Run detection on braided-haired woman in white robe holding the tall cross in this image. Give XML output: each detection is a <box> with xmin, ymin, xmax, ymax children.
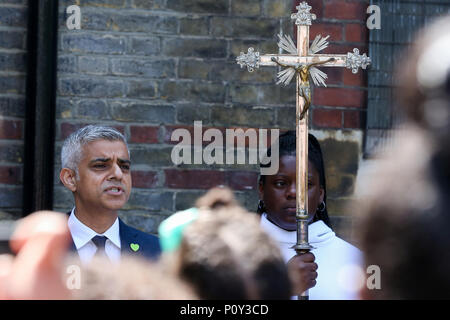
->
<box><xmin>258</xmin><ymin>131</ymin><xmax>362</xmax><ymax>300</ymax></box>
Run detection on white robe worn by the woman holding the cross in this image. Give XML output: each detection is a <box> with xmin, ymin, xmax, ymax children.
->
<box><xmin>261</xmin><ymin>213</ymin><xmax>365</xmax><ymax>300</ymax></box>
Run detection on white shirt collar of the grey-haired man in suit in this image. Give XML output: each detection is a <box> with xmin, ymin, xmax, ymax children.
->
<box><xmin>68</xmin><ymin>207</ymin><xmax>120</xmax><ymax>249</ymax></box>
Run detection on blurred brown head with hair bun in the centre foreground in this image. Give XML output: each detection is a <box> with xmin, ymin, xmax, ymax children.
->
<box><xmin>163</xmin><ymin>189</ymin><xmax>290</xmax><ymax>299</ymax></box>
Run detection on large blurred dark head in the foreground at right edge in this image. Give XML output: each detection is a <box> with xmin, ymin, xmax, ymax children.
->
<box><xmin>360</xmin><ymin>16</ymin><xmax>450</xmax><ymax>299</ymax></box>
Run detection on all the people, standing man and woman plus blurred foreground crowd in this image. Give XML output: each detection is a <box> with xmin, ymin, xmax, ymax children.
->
<box><xmin>0</xmin><ymin>17</ymin><xmax>450</xmax><ymax>300</ymax></box>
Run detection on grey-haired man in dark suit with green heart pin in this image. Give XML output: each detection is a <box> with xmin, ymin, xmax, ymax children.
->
<box><xmin>60</xmin><ymin>125</ymin><xmax>161</xmax><ymax>263</ymax></box>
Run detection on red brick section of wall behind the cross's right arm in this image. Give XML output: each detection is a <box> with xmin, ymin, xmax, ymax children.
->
<box><xmin>306</xmin><ymin>0</ymin><xmax>369</xmax><ymax>129</ymax></box>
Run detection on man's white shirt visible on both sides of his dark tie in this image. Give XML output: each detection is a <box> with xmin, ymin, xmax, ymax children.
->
<box><xmin>68</xmin><ymin>208</ymin><xmax>120</xmax><ymax>264</ymax></box>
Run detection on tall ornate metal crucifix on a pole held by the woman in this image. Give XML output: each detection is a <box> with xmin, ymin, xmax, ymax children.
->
<box><xmin>236</xmin><ymin>2</ymin><xmax>370</xmax><ymax>300</ymax></box>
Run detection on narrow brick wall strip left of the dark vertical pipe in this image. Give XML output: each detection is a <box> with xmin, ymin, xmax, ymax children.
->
<box><xmin>0</xmin><ymin>0</ymin><xmax>27</xmax><ymax>219</ymax></box>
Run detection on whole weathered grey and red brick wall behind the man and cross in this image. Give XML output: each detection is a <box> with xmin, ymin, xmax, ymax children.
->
<box><xmin>0</xmin><ymin>0</ymin><xmax>368</xmax><ymax>244</ymax></box>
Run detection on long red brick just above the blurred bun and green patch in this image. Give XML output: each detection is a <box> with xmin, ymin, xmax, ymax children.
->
<box><xmin>164</xmin><ymin>169</ymin><xmax>225</xmax><ymax>189</ymax></box>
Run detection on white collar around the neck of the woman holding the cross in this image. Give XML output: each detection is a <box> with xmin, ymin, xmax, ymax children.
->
<box><xmin>261</xmin><ymin>213</ymin><xmax>335</xmax><ymax>246</ymax></box>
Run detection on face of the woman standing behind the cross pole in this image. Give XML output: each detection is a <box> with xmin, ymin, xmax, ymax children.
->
<box><xmin>258</xmin><ymin>156</ymin><xmax>324</xmax><ymax>231</ymax></box>
